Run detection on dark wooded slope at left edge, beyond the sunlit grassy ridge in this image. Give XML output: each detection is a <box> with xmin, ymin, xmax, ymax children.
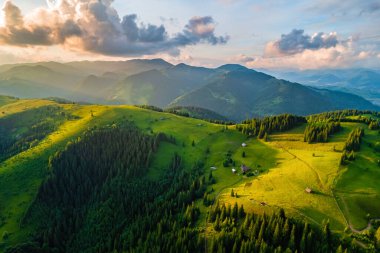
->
<box><xmin>0</xmin><ymin>106</ymin><xmax>73</xmax><ymax>161</ymax></box>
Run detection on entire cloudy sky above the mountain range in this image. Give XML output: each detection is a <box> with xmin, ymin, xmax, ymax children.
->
<box><xmin>0</xmin><ymin>0</ymin><xmax>380</xmax><ymax>70</ymax></box>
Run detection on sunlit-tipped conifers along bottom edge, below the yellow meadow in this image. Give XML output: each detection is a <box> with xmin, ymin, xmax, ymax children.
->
<box><xmin>208</xmin><ymin>203</ymin><xmax>342</xmax><ymax>253</ymax></box>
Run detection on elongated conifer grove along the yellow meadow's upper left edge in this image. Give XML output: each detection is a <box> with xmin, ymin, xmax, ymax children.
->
<box><xmin>236</xmin><ymin>114</ymin><xmax>306</xmax><ymax>139</ymax></box>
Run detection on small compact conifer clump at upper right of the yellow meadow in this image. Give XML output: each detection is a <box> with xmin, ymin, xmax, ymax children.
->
<box><xmin>304</xmin><ymin>121</ymin><xmax>341</xmax><ymax>143</ymax></box>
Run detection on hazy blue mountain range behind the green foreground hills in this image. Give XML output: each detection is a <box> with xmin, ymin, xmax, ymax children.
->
<box><xmin>0</xmin><ymin>59</ymin><xmax>380</xmax><ymax>120</ymax></box>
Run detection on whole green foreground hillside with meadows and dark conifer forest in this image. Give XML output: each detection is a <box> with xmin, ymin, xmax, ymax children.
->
<box><xmin>0</xmin><ymin>99</ymin><xmax>380</xmax><ymax>252</ymax></box>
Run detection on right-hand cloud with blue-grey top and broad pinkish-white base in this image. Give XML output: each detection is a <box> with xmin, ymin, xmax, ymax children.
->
<box><xmin>238</xmin><ymin>29</ymin><xmax>378</xmax><ymax>69</ymax></box>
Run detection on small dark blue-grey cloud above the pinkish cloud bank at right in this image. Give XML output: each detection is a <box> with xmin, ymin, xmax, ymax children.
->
<box><xmin>274</xmin><ymin>29</ymin><xmax>339</xmax><ymax>54</ymax></box>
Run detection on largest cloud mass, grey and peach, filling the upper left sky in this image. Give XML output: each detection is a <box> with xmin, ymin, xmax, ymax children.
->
<box><xmin>0</xmin><ymin>0</ymin><xmax>229</xmax><ymax>56</ymax></box>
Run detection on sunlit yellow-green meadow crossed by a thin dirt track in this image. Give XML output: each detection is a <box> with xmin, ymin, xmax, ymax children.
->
<box><xmin>215</xmin><ymin>122</ymin><xmax>358</xmax><ymax>230</ymax></box>
